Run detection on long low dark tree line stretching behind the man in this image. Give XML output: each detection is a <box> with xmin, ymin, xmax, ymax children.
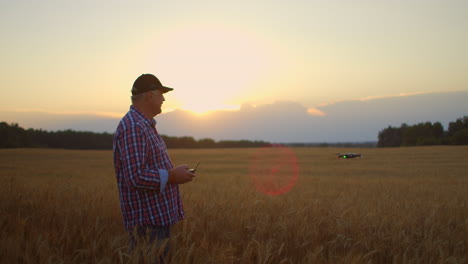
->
<box><xmin>0</xmin><ymin>122</ymin><xmax>269</xmax><ymax>150</ymax></box>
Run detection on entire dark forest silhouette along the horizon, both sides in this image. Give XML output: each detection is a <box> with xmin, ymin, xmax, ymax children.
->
<box><xmin>0</xmin><ymin>116</ymin><xmax>468</xmax><ymax>150</ymax></box>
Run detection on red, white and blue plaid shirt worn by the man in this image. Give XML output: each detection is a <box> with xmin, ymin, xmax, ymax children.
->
<box><xmin>114</xmin><ymin>106</ymin><xmax>184</xmax><ymax>231</ymax></box>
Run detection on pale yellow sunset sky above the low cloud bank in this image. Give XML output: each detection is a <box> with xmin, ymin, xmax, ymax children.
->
<box><xmin>0</xmin><ymin>0</ymin><xmax>468</xmax><ymax>141</ymax></box>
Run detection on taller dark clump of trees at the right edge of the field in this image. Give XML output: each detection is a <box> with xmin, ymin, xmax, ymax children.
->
<box><xmin>377</xmin><ymin>116</ymin><xmax>468</xmax><ymax>147</ymax></box>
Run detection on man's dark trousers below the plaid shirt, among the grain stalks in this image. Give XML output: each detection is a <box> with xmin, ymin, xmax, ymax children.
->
<box><xmin>130</xmin><ymin>226</ymin><xmax>171</xmax><ymax>264</ymax></box>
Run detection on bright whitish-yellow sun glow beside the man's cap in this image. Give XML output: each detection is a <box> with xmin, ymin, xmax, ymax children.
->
<box><xmin>151</xmin><ymin>24</ymin><xmax>284</xmax><ymax>114</ymax></box>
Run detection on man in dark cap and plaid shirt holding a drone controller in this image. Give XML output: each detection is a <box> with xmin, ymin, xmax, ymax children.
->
<box><xmin>114</xmin><ymin>74</ymin><xmax>195</xmax><ymax>254</ymax></box>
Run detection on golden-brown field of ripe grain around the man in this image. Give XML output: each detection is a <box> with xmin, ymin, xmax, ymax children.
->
<box><xmin>0</xmin><ymin>146</ymin><xmax>468</xmax><ymax>263</ymax></box>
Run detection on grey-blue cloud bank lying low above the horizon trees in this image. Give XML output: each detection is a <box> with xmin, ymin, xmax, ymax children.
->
<box><xmin>0</xmin><ymin>91</ymin><xmax>468</xmax><ymax>143</ymax></box>
